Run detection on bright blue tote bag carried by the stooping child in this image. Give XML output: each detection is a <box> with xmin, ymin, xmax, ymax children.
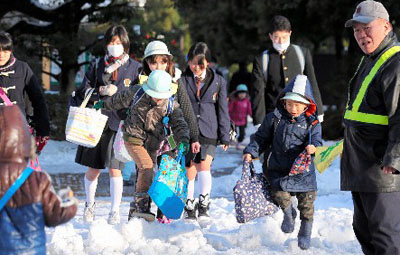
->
<box><xmin>148</xmin><ymin>152</ymin><xmax>188</xmax><ymax>219</ymax></box>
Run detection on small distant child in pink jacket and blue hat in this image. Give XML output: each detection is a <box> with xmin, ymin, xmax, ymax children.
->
<box><xmin>229</xmin><ymin>84</ymin><xmax>252</xmax><ymax>150</ymax></box>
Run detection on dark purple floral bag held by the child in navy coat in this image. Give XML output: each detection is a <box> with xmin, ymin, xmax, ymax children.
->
<box><xmin>233</xmin><ymin>162</ymin><xmax>278</xmax><ymax>223</ymax></box>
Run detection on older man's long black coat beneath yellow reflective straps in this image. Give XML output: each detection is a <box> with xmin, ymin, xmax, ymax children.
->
<box><xmin>341</xmin><ymin>33</ymin><xmax>400</xmax><ymax>192</ymax></box>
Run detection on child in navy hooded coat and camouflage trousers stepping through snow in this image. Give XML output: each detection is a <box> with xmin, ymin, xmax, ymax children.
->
<box><xmin>243</xmin><ymin>75</ymin><xmax>322</xmax><ymax>250</ymax></box>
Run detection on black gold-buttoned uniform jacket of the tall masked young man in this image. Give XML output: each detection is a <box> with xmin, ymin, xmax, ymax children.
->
<box><xmin>250</xmin><ymin>45</ymin><xmax>324</xmax><ymax>125</ymax></box>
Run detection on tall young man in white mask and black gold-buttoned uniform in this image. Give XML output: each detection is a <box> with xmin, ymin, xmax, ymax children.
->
<box><xmin>249</xmin><ymin>16</ymin><xmax>323</xmax><ymax>125</ymax></box>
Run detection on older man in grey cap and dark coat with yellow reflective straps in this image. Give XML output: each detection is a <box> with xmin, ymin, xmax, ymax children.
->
<box><xmin>341</xmin><ymin>1</ymin><xmax>400</xmax><ymax>255</ymax></box>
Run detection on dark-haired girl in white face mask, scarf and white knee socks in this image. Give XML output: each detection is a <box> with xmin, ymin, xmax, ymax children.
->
<box><xmin>75</xmin><ymin>25</ymin><xmax>140</xmax><ymax>224</ymax></box>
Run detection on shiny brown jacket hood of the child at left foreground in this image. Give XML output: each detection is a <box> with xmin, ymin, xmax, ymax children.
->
<box><xmin>0</xmin><ymin>105</ymin><xmax>31</xmax><ymax>164</ymax></box>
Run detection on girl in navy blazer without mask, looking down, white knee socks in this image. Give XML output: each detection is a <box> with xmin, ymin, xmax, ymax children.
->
<box><xmin>179</xmin><ymin>42</ymin><xmax>230</xmax><ymax>219</ymax></box>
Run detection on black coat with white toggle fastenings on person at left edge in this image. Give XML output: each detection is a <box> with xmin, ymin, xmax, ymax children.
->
<box><xmin>0</xmin><ymin>59</ymin><xmax>50</xmax><ymax>136</ymax></box>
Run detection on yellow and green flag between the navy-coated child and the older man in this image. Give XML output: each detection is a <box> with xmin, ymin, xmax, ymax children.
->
<box><xmin>314</xmin><ymin>140</ymin><xmax>343</xmax><ymax>174</ymax></box>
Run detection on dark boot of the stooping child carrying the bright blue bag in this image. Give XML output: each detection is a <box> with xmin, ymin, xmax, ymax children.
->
<box><xmin>128</xmin><ymin>193</ymin><xmax>155</xmax><ymax>222</ymax></box>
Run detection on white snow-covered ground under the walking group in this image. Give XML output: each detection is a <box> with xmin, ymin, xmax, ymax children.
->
<box><xmin>40</xmin><ymin>127</ymin><xmax>362</xmax><ymax>255</ymax></box>
